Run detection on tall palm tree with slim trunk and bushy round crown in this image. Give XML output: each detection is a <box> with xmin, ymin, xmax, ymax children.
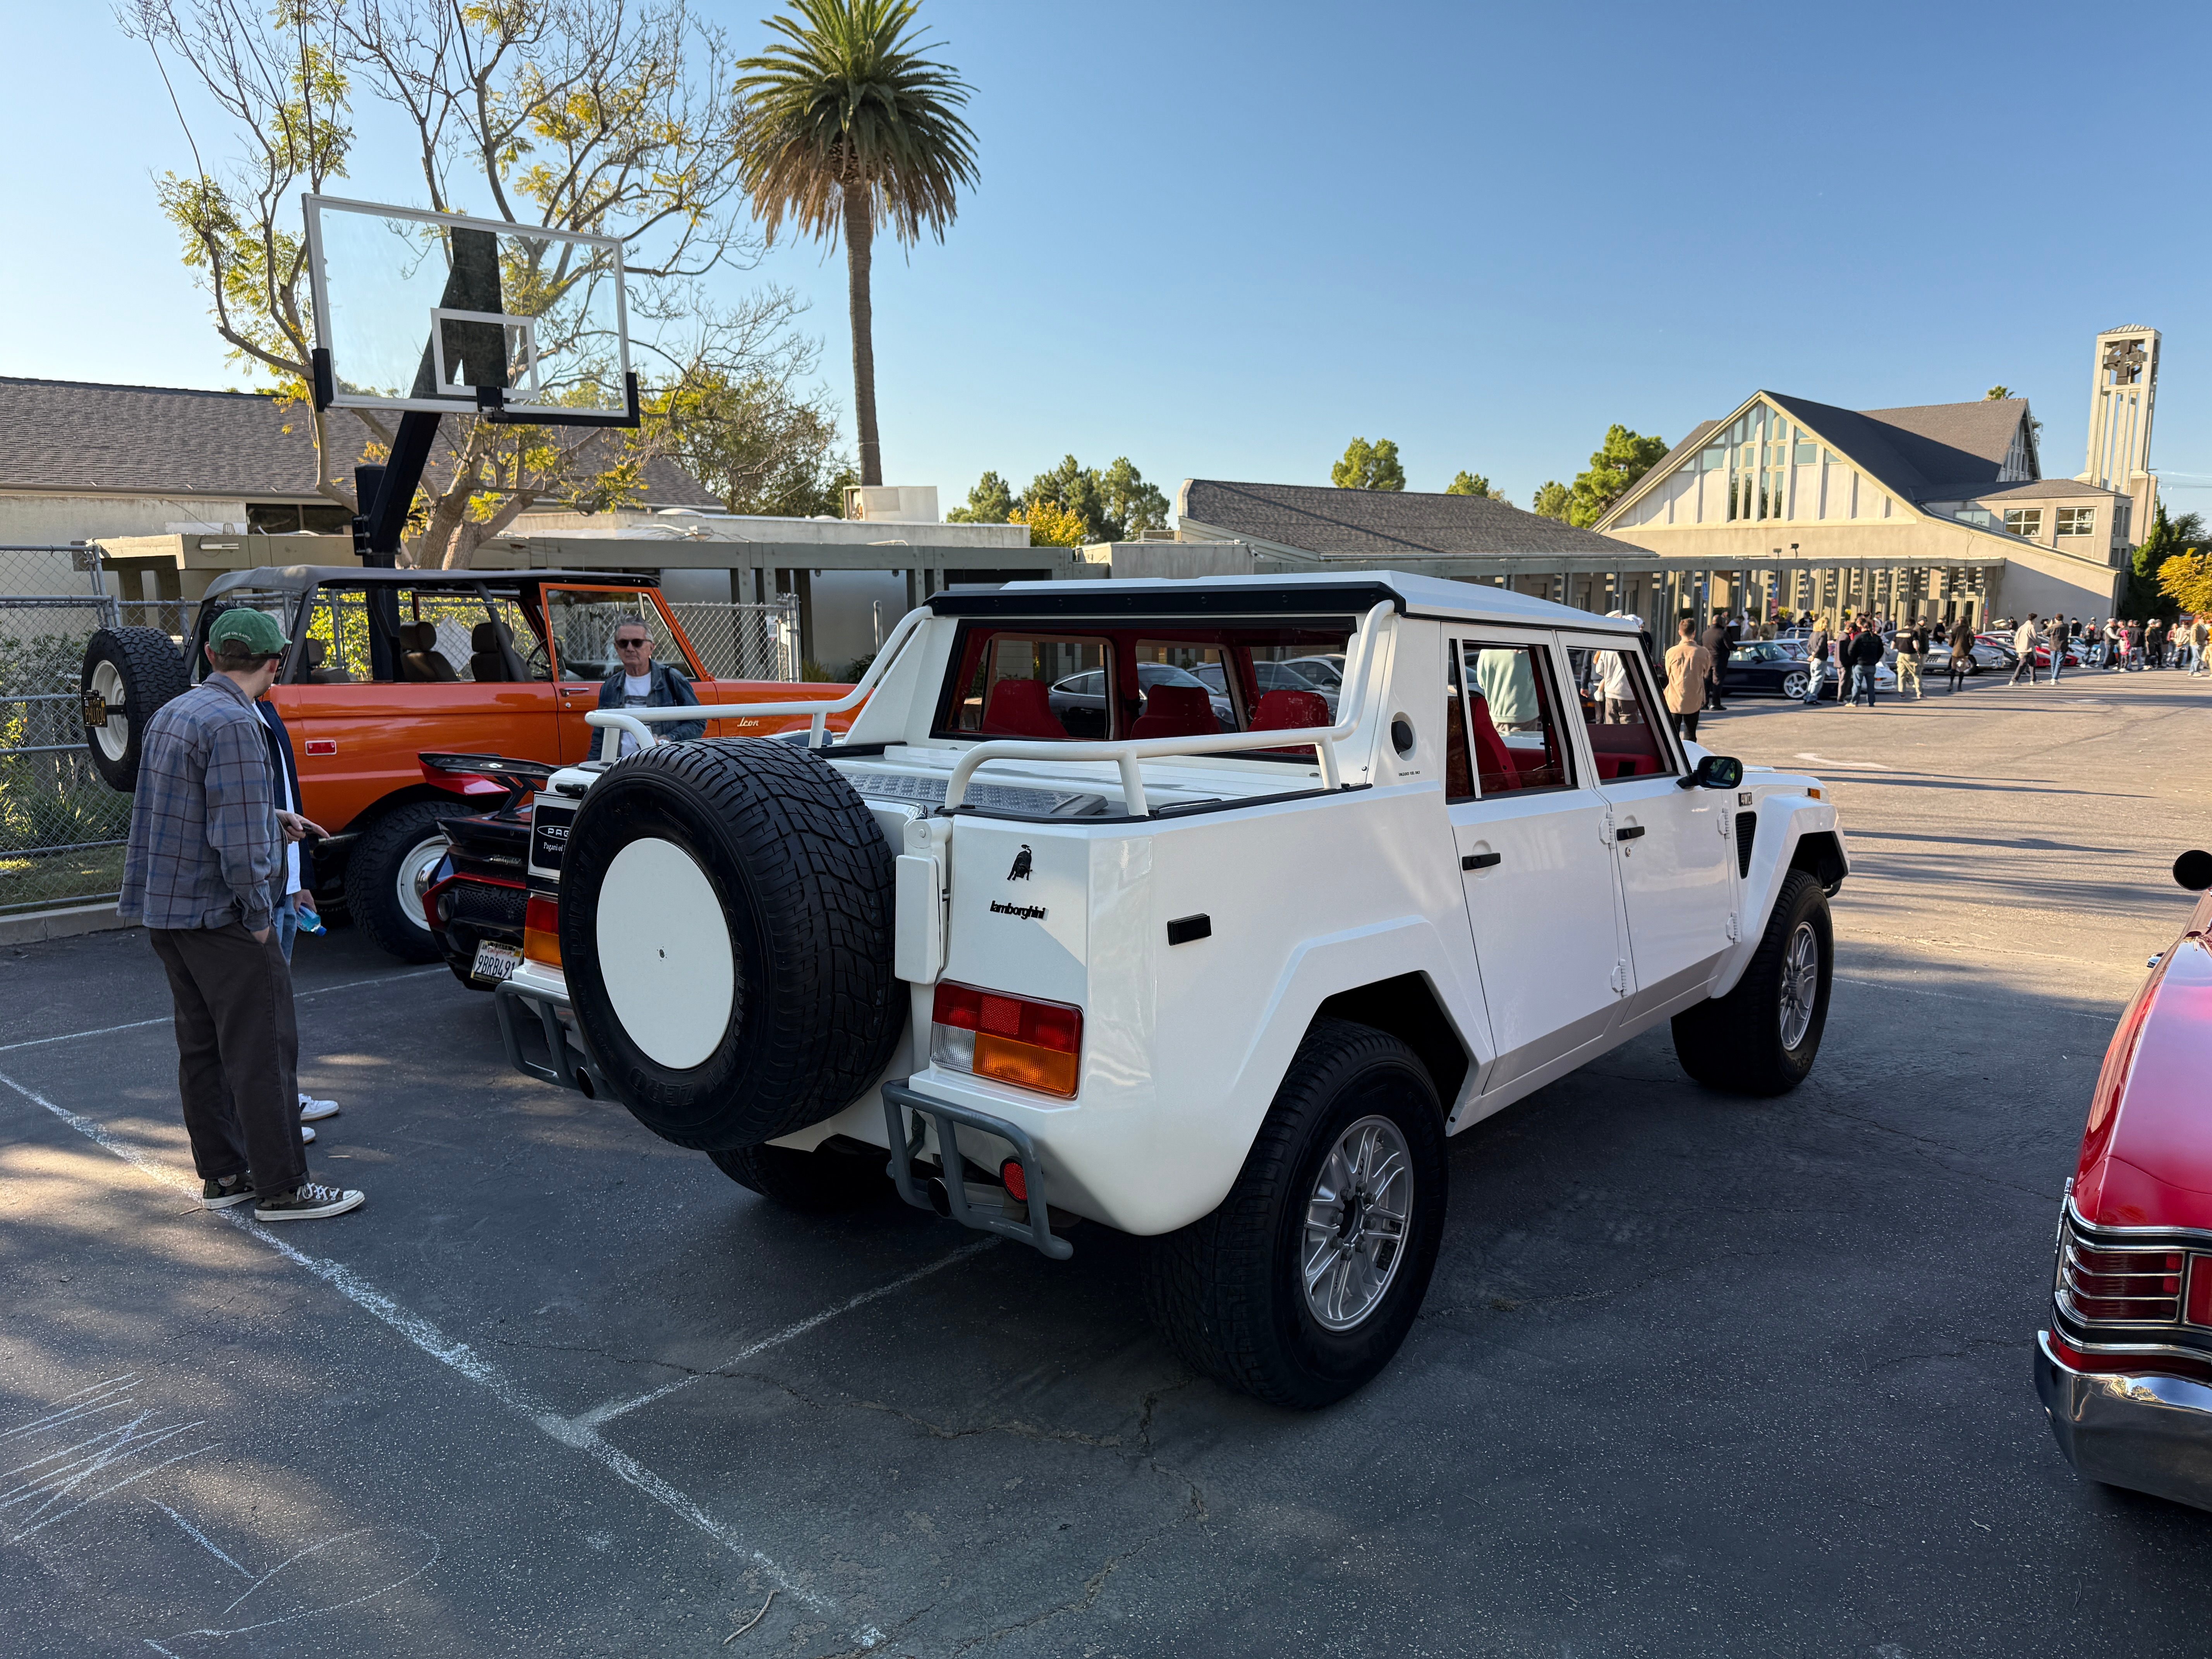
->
<box><xmin>737</xmin><ymin>0</ymin><xmax>975</xmax><ymax>484</ymax></box>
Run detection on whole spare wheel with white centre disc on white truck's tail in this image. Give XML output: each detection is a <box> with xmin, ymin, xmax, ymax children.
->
<box><xmin>560</xmin><ymin>739</ymin><xmax>907</xmax><ymax>1150</ymax></box>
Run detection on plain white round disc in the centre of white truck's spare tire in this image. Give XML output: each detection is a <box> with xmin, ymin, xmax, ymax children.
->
<box><xmin>595</xmin><ymin>836</ymin><xmax>737</xmax><ymax>1071</ymax></box>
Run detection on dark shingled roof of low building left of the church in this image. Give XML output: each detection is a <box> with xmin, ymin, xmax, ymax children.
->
<box><xmin>1177</xmin><ymin>478</ymin><xmax>1654</xmax><ymax>560</ymax></box>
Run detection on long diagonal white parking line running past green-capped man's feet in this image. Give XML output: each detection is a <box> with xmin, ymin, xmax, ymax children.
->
<box><xmin>0</xmin><ymin>1070</ymin><xmax>883</xmax><ymax>1648</ymax></box>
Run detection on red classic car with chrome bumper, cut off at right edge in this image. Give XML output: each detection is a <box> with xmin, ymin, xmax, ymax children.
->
<box><xmin>2035</xmin><ymin>852</ymin><xmax>2212</xmax><ymax>1509</ymax></box>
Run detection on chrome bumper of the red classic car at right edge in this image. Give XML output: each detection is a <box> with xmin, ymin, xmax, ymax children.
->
<box><xmin>2035</xmin><ymin>1332</ymin><xmax>2212</xmax><ymax>1509</ymax></box>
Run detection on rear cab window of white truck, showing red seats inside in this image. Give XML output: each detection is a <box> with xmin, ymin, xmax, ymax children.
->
<box><xmin>933</xmin><ymin>617</ymin><xmax>1352</xmax><ymax>761</ymax></box>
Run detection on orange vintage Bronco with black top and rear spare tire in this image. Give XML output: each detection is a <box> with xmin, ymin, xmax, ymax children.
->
<box><xmin>82</xmin><ymin>564</ymin><xmax>852</xmax><ymax>962</ymax></box>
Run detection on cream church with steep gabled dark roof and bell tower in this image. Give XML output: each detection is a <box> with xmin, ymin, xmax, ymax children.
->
<box><xmin>1597</xmin><ymin>336</ymin><xmax>2154</xmax><ymax>619</ymax></box>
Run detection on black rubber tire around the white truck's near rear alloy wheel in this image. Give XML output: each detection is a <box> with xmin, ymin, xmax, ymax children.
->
<box><xmin>1144</xmin><ymin>1018</ymin><xmax>1449</xmax><ymax>1411</ymax></box>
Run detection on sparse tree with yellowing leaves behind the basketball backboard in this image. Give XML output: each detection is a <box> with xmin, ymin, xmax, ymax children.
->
<box><xmin>119</xmin><ymin>0</ymin><xmax>787</xmax><ymax>566</ymax></box>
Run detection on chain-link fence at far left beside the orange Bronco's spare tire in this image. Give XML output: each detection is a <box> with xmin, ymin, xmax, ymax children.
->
<box><xmin>0</xmin><ymin>546</ymin><xmax>140</xmax><ymax>916</ymax></box>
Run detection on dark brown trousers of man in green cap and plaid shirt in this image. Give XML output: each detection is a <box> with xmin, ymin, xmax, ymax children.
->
<box><xmin>146</xmin><ymin>922</ymin><xmax>307</xmax><ymax>1197</ymax></box>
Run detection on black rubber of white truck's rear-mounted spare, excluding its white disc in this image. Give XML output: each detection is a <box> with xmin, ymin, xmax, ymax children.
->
<box><xmin>560</xmin><ymin>739</ymin><xmax>907</xmax><ymax>1150</ymax></box>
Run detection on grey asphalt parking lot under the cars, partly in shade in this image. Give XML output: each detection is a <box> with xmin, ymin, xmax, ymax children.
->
<box><xmin>0</xmin><ymin>675</ymin><xmax>2212</xmax><ymax>1659</ymax></box>
